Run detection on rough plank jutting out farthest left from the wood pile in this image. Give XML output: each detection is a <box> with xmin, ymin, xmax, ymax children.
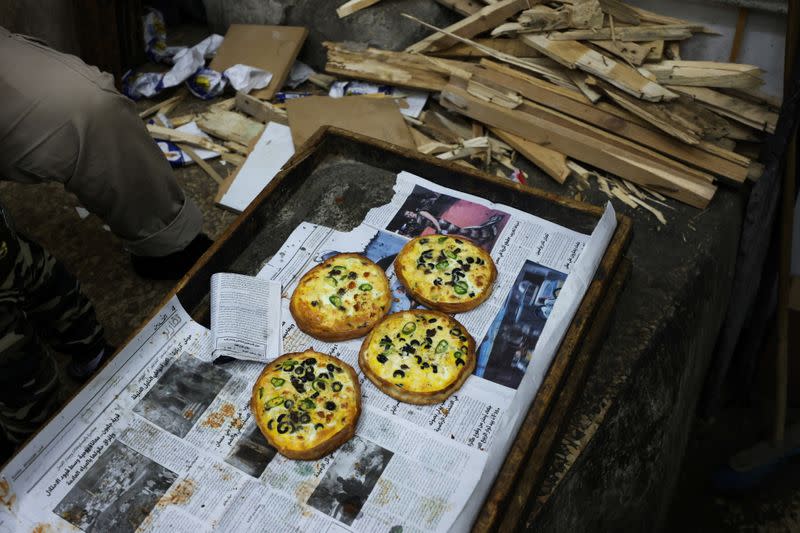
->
<box><xmin>323</xmin><ymin>42</ymin><xmax>465</xmax><ymax>92</ymax></box>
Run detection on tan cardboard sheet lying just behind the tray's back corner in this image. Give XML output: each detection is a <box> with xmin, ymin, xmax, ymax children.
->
<box><xmin>286</xmin><ymin>96</ymin><xmax>415</xmax><ymax>149</ymax></box>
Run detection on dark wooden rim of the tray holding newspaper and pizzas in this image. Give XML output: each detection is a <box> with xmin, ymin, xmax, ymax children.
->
<box><xmin>7</xmin><ymin>127</ymin><xmax>632</xmax><ymax>531</ymax></box>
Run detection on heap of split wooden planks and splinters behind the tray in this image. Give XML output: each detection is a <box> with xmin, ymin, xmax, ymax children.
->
<box><xmin>326</xmin><ymin>0</ymin><xmax>778</xmax><ymax>220</ymax></box>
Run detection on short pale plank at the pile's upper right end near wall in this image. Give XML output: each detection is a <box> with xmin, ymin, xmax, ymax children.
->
<box><xmin>645</xmin><ymin>61</ymin><xmax>764</xmax><ymax>89</ymax></box>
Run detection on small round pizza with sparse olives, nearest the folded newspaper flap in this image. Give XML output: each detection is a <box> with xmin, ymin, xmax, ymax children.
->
<box><xmin>289</xmin><ymin>254</ymin><xmax>392</xmax><ymax>342</ymax></box>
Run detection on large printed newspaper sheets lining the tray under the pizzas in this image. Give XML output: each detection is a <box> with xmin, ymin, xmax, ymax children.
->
<box><xmin>0</xmin><ymin>173</ymin><xmax>615</xmax><ymax>533</ymax></box>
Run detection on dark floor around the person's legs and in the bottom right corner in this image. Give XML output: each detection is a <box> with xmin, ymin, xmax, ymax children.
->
<box><xmin>0</xmin><ymin>89</ymin><xmax>800</xmax><ymax>531</ymax></box>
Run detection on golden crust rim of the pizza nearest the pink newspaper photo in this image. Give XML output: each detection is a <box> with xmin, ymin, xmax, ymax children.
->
<box><xmin>395</xmin><ymin>235</ymin><xmax>497</xmax><ymax>313</ymax></box>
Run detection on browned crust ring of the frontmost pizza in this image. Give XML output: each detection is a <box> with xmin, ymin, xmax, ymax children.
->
<box><xmin>250</xmin><ymin>350</ymin><xmax>361</xmax><ymax>461</ymax></box>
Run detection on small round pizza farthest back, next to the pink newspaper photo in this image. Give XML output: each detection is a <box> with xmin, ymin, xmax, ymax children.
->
<box><xmin>394</xmin><ymin>235</ymin><xmax>497</xmax><ymax>313</ymax></box>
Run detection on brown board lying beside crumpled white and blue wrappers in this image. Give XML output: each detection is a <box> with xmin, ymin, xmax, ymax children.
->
<box><xmin>211</xmin><ymin>24</ymin><xmax>308</xmax><ymax>100</ymax></box>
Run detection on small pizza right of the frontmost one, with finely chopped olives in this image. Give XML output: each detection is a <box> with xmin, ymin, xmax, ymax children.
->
<box><xmin>358</xmin><ymin>310</ymin><xmax>475</xmax><ymax>405</ymax></box>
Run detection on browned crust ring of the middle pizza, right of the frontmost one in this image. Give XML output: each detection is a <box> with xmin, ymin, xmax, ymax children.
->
<box><xmin>358</xmin><ymin>309</ymin><xmax>476</xmax><ymax>405</ymax></box>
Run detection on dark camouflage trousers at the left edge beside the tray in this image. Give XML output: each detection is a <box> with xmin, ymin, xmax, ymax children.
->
<box><xmin>0</xmin><ymin>206</ymin><xmax>105</xmax><ymax>444</ymax></box>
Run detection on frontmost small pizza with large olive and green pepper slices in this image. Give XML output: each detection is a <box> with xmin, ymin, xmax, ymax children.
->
<box><xmin>250</xmin><ymin>350</ymin><xmax>361</xmax><ymax>461</ymax></box>
